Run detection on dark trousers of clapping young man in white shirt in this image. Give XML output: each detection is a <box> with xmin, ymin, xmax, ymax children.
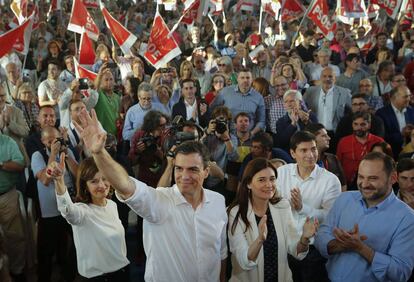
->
<box><xmin>288</xmin><ymin>245</ymin><xmax>329</xmax><ymax>282</ymax></box>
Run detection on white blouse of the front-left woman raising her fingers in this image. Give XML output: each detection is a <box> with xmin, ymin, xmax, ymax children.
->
<box><xmin>56</xmin><ymin>191</ymin><xmax>129</xmax><ymax>278</ymax></box>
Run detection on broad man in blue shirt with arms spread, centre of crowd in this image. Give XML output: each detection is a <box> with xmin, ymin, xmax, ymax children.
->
<box><xmin>211</xmin><ymin>69</ymin><xmax>266</xmax><ymax>135</ymax></box>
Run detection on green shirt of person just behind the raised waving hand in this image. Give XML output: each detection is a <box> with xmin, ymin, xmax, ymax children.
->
<box><xmin>95</xmin><ymin>90</ymin><xmax>121</xmax><ymax>136</ymax></box>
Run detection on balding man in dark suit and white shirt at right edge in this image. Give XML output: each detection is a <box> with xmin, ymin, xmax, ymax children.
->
<box><xmin>376</xmin><ymin>86</ymin><xmax>414</xmax><ymax>158</ymax></box>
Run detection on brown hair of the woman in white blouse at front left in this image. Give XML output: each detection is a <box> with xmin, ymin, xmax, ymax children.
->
<box><xmin>76</xmin><ymin>158</ymin><xmax>113</xmax><ymax>204</ymax></box>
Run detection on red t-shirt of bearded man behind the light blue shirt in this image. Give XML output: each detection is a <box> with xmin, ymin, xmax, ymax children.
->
<box><xmin>336</xmin><ymin>133</ymin><xmax>384</xmax><ymax>184</ymax></box>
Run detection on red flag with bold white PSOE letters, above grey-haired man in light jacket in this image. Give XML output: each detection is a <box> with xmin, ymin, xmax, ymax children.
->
<box><xmin>308</xmin><ymin>0</ymin><xmax>333</xmax><ymax>40</ymax></box>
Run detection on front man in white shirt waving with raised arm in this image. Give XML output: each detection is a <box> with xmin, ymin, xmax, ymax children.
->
<box><xmin>72</xmin><ymin>111</ymin><xmax>227</xmax><ymax>282</ymax></box>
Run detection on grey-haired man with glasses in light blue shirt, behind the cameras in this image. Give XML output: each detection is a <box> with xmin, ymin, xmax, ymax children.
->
<box><xmin>122</xmin><ymin>82</ymin><xmax>164</xmax><ymax>141</ymax></box>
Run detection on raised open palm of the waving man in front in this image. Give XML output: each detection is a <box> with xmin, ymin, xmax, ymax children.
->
<box><xmin>73</xmin><ymin>110</ymin><xmax>106</xmax><ymax>154</ymax></box>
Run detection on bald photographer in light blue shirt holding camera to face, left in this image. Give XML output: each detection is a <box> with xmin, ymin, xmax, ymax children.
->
<box><xmin>31</xmin><ymin>127</ymin><xmax>78</xmax><ymax>281</ymax></box>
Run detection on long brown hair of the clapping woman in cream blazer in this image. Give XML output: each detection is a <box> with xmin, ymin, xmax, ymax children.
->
<box><xmin>227</xmin><ymin>158</ymin><xmax>281</xmax><ymax>234</ymax></box>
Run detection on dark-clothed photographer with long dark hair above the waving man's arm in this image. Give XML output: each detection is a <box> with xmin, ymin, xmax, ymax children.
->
<box><xmin>128</xmin><ymin>111</ymin><xmax>168</xmax><ymax>187</ymax></box>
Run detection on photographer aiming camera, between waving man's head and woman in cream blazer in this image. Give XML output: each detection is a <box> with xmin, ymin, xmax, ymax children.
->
<box><xmin>201</xmin><ymin>106</ymin><xmax>238</xmax><ymax>203</ymax></box>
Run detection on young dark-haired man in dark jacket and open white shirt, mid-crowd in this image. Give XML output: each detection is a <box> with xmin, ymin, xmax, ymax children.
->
<box><xmin>171</xmin><ymin>78</ymin><xmax>209</xmax><ymax>127</ymax></box>
